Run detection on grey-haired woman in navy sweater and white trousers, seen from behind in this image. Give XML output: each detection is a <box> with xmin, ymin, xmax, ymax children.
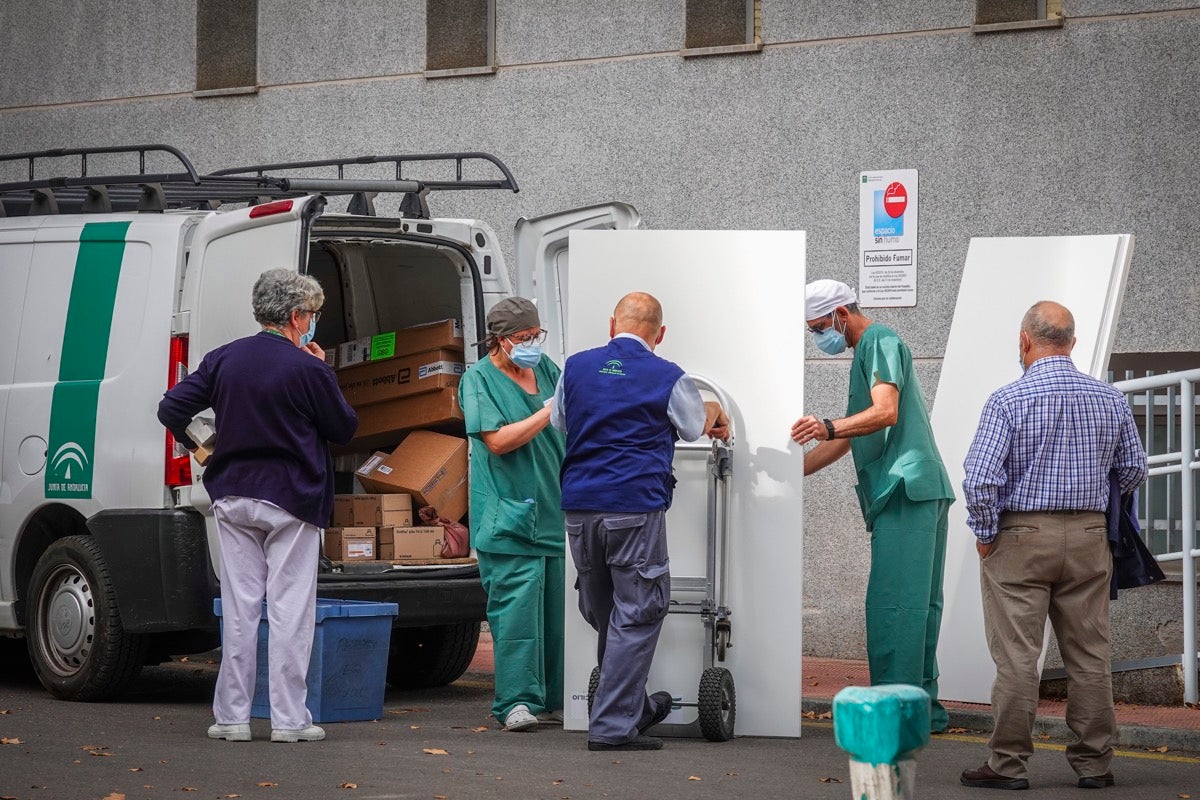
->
<box><xmin>158</xmin><ymin>269</ymin><xmax>359</xmax><ymax>742</ymax></box>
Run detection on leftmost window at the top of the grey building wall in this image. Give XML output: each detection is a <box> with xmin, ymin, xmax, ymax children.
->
<box><xmin>196</xmin><ymin>0</ymin><xmax>258</xmax><ymax>95</ymax></box>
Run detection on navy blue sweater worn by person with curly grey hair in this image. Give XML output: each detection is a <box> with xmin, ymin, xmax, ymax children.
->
<box><xmin>158</xmin><ymin>331</ymin><xmax>359</xmax><ymax>528</ymax></box>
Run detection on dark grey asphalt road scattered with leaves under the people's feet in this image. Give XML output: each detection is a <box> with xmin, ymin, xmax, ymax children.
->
<box><xmin>0</xmin><ymin>640</ymin><xmax>1200</xmax><ymax>800</ymax></box>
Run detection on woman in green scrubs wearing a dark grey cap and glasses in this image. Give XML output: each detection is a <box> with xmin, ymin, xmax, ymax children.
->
<box><xmin>458</xmin><ymin>297</ymin><xmax>565</xmax><ymax>730</ymax></box>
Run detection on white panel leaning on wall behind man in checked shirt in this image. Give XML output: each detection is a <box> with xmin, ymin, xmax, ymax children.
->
<box><xmin>932</xmin><ymin>234</ymin><xmax>1133</xmax><ymax>703</ymax></box>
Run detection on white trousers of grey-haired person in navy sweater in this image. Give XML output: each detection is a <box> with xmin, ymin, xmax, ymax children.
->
<box><xmin>212</xmin><ymin>497</ymin><xmax>320</xmax><ymax>730</ymax></box>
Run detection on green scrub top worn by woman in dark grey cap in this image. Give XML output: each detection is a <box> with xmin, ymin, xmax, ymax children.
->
<box><xmin>458</xmin><ymin>356</ymin><xmax>566</xmax><ymax>557</ymax></box>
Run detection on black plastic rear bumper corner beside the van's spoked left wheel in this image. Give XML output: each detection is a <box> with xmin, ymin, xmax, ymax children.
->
<box><xmin>88</xmin><ymin>509</ymin><xmax>220</xmax><ymax>633</ymax></box>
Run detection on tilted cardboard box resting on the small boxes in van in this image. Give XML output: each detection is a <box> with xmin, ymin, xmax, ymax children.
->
<box><xmin>354</xmin><ymin>434</ymin><xmax>467</xmax><ymax>521</ymax></box>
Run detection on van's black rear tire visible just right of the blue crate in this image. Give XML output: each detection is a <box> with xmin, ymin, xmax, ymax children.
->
<box><xmin>388</xmin><ymin>621</ymin><xmax>479</xmax><ymax>688</ymax></box>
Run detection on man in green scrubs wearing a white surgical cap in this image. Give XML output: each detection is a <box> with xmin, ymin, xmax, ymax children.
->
<box><xmin>792</xmin><ymin>279</ymin><xmax>954</xmax><ymax>732</ymax></box>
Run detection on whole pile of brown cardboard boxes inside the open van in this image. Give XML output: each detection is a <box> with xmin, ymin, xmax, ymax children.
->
<box><xmin>324</xmin><ymin>319</ymin><xmax>467</xmax><ymax>561</ymax></box>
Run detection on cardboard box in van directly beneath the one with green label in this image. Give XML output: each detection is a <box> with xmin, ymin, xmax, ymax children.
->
<box><xmin>337</xmin><ymin>350</ymin><xmax>467</xmax><ymax>408</ymax></box>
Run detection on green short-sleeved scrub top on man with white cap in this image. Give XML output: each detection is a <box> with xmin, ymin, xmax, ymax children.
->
<box><xmin>846</xmin><ymin>324</ymin><xmax>954</xmax><ymax>530</ymax></box>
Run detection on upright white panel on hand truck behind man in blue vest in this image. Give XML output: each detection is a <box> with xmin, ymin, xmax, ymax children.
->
<box><xmin>565</xmin><ymin>230</ymin><xmax>805</xmax><ymax>736</ymax></box>
